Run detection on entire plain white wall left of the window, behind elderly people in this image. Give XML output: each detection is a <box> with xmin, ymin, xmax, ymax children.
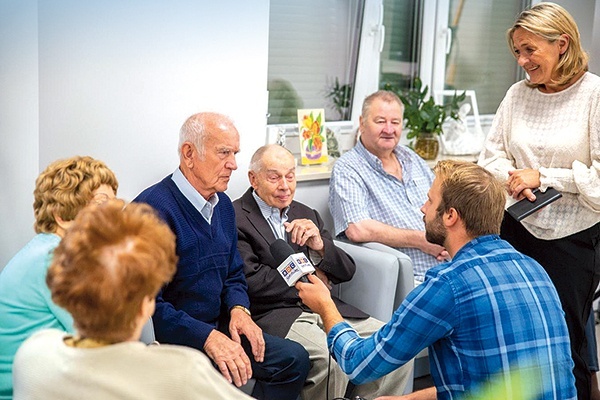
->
<box><xmin>0</xmin><ymin>0</ymin><xmax>269</xmax><ymax>268</ymax></box>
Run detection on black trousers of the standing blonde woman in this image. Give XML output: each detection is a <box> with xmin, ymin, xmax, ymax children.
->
<box><xmin>500</xmin><ymin>213</ymin><xmax>600</xmax><ymax>400</ymax></box>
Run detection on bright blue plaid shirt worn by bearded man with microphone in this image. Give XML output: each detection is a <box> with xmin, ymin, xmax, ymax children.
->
<box><xmin>327</xmin><ymin>235</ymin><xmax>576</xmax><ymax>400</ymax></box>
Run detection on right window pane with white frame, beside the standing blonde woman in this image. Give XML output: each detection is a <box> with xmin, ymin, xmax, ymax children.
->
<box><xmin>432</xmin><ymin>0</ymin><xmax>530</xmax><ymax>114</ymax></box>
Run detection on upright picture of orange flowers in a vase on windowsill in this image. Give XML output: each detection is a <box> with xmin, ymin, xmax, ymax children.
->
<box><xmin>298</xmin><ymin>108</ymin><xmax>328</xmax><ymax>165</ymax></box>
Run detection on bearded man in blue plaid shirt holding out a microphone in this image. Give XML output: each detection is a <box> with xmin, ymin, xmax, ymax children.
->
<box><xmin>296</xmin><ymin>161</ymin><xmax>576</xmax><ymax>399</ymax></box>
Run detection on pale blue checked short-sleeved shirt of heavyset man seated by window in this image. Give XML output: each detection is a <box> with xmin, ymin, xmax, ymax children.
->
<box><xmin>329</xmin><ymin>141</ymin><xmax>439</xmax><ymax>281</ymax></box>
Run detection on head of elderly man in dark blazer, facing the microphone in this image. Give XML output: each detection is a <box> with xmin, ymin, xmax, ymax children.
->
<box><xmin>248</xmin><ymin>144</ymin><xmax>296</xmax><ymax>209</ymax></box>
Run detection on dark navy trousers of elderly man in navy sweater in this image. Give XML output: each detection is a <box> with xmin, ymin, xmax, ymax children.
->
<box><xmin>242</xmin><ymin>332</ymin><xmax>310</xmax><ymax>400</ymax></box>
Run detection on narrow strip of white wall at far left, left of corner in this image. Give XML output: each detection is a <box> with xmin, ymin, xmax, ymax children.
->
<box><xmin>0</xmin><ymin>0</ymin><xmax>39</xmax><ymax>269</ymax></box>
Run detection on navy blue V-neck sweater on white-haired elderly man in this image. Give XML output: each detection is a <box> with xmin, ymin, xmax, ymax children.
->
<box><xmin>134</xmin><ymin>175</ymin><xmax>250</xmax><ymax>350</ymax></box>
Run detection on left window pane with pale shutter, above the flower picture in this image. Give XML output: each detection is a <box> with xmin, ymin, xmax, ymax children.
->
<box><xmin>267</xmin><ymin>0</ymin><xmax>364</xmax><ymax>124</ymax></box>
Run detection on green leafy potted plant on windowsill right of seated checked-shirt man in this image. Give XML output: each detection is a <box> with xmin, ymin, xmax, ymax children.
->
<box><xmin>384</xmin><ymin>78</ymin><xmax>466</xmax><ymax>160</ymax></box>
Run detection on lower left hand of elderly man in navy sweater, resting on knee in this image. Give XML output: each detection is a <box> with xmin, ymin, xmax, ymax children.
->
<box><xmin>204</xmin><ymin>330</ymin><xmax>252</xmax><ymax>387</ymax></box>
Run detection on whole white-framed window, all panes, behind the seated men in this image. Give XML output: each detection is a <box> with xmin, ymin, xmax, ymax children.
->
<box><xmin>267</xmin><ymin>0</ymin><xmax>531</xmax><ymax>130</ymax></box>
